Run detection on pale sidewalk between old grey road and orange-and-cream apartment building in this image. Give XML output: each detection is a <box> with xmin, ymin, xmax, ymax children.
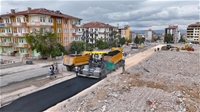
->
<box><xmin>0</xmin><ymin>56</ymin><xmax>63</xmax><ymax>76</ymax></box>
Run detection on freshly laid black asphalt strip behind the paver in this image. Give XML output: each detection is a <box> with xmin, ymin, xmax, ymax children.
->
<box><xmin>0</xmin><ymin>77</ymin><xmax>100</xmax><ymax>112</ymax></box>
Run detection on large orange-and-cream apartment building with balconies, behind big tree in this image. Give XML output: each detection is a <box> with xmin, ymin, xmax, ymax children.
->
<box><xmin>0</xmin><ymin>7</ymin><xmax>81</xmax><ymax>57</ymax></box>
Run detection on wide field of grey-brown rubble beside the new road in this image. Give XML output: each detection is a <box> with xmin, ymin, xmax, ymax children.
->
<box><xmin>46</xmin><ymin>44</ymin><xmax>200</xmax><ymax>112</ymax></box>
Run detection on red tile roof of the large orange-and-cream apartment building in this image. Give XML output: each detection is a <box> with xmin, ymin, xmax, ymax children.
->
<box><xmin>0</xmin><ymin>8</ymin><xmax>82</xmax><ymax>20</ymax></box>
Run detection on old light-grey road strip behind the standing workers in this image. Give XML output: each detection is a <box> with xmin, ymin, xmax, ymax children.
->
<box><xmin>0</xmin><ymin>64</ymin><xmax>65</xmax><ymax>87</ymax></box>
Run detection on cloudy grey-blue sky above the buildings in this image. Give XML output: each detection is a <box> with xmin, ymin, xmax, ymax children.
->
<box><xmin>0</xmin><ymin>0</ymin><xmax>200</xmax><ymax>31</ymax></box>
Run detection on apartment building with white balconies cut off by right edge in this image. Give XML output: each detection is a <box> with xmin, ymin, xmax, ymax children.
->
<box><xmin>186</xmin><ymin>22</ymin><xmax>200</xmax><ymax>43</ymax></box>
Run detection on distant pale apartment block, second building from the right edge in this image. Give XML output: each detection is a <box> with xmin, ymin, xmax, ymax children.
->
<box><xmin>165</xmin><ymin>26</ymin><xmax>181</xmax><ymax>43</ymax></box>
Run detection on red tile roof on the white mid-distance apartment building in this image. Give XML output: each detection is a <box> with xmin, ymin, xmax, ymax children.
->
<box><xmin>81</xmin><ymin>22</ymin><xmax>117</xmax><ymax>28</ymax></box>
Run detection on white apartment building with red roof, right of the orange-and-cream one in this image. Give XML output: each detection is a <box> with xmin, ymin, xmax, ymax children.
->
<box><xmin>79</xmin><ymin>22</ymin><xmax>117</xmax><ymax>44</ymax></box>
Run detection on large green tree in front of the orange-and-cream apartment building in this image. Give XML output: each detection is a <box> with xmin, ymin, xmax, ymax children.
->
<box><xmin>25</xmin><ymin>28</ymin><xmax>63</xmax><ymax>58</ymax></box>
